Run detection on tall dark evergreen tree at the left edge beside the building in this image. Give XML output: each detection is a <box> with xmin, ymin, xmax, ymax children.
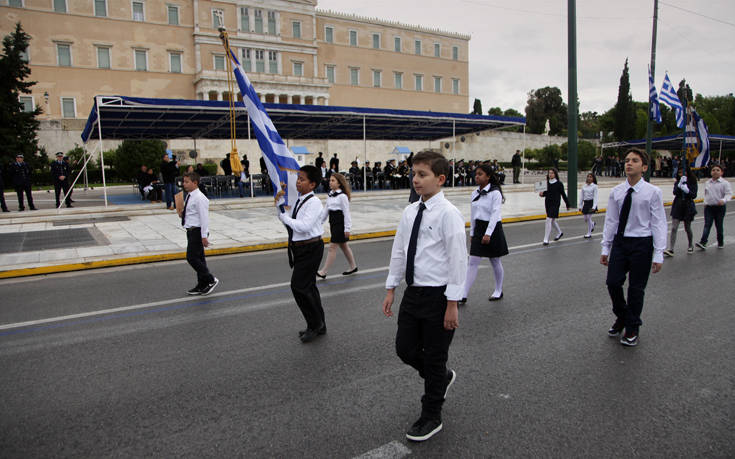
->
<box><xmin>0</xmin><ymin>23</ymin><xmax>48</xmax><ymax>170</ymax></box>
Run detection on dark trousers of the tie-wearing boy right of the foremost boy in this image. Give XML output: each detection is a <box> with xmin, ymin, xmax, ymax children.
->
<box><xmin>607</xmin><ymin>236</ymin><xmax>653</xmax><ymax>332</ymax></box>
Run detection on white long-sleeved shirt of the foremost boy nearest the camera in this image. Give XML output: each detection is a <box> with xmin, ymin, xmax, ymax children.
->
<box><xmin>385</xmin><ymin>191</ymin><xmax>467</xmax><ymax>301</ymax></box>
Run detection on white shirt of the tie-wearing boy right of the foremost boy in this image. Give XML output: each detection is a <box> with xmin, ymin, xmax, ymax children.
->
<box><xmin>602</xmin><ymin>179</ymin><xmax>668</xmax><ymax>263</ymax></box>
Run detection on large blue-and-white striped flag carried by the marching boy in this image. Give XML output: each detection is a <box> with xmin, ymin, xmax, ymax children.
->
<box><xmin>230</xmin><ymin>50</ymin><xmax>301</xmax><ymax>206</ymax></box>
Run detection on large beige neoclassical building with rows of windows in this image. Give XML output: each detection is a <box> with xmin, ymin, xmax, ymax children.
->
<box><xmin>0</xmin><ymin>0</ymin><xmax>470</xmax><ymax>124</ymax></box>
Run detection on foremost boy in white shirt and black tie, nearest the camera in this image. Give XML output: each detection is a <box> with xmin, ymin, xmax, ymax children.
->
<box><xmin>383</xmin><ymin>151</ymin><xmax>467</xmax><ymax>441</ymax></box>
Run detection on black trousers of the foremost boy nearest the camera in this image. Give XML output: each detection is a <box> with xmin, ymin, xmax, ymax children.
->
<box><xmin>396</xmin><ymin>287</ymin><xmax>454</xmax><ymax>420</ymax></box>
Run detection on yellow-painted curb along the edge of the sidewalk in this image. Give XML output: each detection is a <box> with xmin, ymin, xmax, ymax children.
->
<box><xmin>0</xmin><ymin>199</ymin><xmax>704</xmax><ymax>279</ymax></box>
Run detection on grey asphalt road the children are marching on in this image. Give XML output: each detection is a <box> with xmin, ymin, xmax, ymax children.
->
<box><xmin>0</xmin><ymin>208</ymin><xmax>735</xmax><ymax>458</ymax></box>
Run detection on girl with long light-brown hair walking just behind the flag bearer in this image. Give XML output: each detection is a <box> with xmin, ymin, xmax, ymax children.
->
<box><xmin>316</xmin><ymin>172</ymin><xmax>357</xmax><ymax>279</ymax></box>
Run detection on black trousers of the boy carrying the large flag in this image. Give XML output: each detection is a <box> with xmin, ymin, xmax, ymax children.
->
<box><xmin>291</xmin><ymin>239</ymin><xmax>326</xmax><ymax>330</ymax></box>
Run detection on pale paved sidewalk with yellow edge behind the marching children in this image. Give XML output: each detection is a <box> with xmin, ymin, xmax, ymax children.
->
<box><xmin>0</xmin><ymin>175</ymin><xmax>724</xmax><ymax>278</ymax></box>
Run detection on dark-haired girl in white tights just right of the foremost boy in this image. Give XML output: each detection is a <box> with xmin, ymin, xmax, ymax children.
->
<box><xmin>460</xmin><ymin>164</ymin><xmax>508</xmax><ymax>303</ymax></box>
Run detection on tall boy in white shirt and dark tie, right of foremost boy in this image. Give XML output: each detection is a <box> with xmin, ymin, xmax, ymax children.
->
<box><xmin>600</xmin><ymin>150</ymin><xmax>667</xmax><ymax>346</ymax></box>
